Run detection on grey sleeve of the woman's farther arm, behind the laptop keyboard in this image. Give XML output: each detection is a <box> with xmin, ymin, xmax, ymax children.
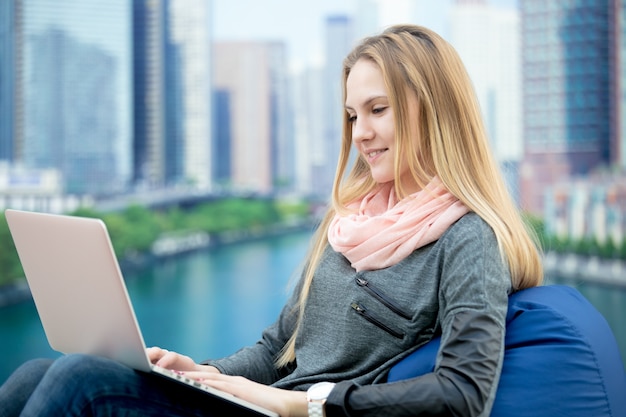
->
<box><xmin>201</xmin><ymin>276</ymin><xmax>300</xmax><ymax>385</ymax></box>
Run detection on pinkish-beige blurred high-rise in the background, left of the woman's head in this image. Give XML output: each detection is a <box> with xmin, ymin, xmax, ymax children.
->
<box><xmin>213</xmin><ymin>41</ymin><xmax>295</xmax><ymax>194</ymax></box>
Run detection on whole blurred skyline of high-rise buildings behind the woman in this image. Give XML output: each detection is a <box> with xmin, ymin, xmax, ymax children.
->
<box><xmin>0</xmin><ymin>0</ymin><xmax>626</xmax><ymax>252</ymax></box>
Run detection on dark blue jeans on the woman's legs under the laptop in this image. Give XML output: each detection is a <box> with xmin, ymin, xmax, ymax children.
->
<box><xmin>0</xmin><ymin>354</ymin><xmax>254</xmax><ymax>417</ymax></box>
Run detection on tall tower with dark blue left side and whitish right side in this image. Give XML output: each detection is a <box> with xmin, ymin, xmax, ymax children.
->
<box><xmin>133</xmin><ymin>0</ymin><xmax>213</xmax><ymax>189</ymax></box>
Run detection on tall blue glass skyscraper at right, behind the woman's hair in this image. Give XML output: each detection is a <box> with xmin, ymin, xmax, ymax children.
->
<box><xmin>522</xmin><ymin>0</ymin><xmax>610</xmax><ymax>165</ymax></box>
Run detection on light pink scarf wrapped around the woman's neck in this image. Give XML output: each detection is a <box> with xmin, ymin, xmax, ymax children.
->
<box><xmin>328</xmin><ymin>177</ymin><xmax>469</xmax><ymax>271</ymax></box>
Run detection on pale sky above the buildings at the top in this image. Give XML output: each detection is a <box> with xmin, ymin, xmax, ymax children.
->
<box><xmin>213</xmin><ymin>0</ymin><xmax>518</xmax><ymax>66</ymax></box>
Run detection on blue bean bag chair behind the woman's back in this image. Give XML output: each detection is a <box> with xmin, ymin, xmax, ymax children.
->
<box><xmin>388</xmin><ymin>285</ymin><xmax>626</xmax><ymax>417</ymax></box>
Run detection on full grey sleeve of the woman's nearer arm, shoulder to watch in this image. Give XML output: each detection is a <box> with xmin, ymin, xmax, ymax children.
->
<box><xmin>326</xmin><ymin>214</ymin><xmax>511</xmax><ymax>417</ymax></box>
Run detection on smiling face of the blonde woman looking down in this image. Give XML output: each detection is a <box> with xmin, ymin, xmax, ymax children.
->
<box><xmin>345</xmin><ymin>59</ymin><xmax>415</xmax><ymax>192</ymax></box>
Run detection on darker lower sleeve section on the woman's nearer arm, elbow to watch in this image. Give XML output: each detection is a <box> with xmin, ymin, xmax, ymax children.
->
<box><xmin>326</xmin><ymin>312</ymin><xmax>503</xmax><ymax>417</ymax></box>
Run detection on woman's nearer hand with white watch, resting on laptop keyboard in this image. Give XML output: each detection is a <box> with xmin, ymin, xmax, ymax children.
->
<box><xmin>184</xmin><ymin>372</ymin><xmax>308</xmax><ymax>417</ymax></box>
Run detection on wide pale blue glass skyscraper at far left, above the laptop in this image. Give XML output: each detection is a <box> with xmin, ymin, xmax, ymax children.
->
<box><xmin>16</xmin><ymin>0</ymin><xmax>132</xmax><ymax>195</ymax></box>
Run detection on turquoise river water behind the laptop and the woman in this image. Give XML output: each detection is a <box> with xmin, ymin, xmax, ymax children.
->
<box><xmin>0</xmin><ymin>233</ymin><xmax>626</xmax><ymax>382</ymax></box>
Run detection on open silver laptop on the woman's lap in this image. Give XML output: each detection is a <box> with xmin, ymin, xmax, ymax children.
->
<box><xmin>5</xmin><ymin>209</ymin><xmax>278</xmax><ymax>417</ymax></box>
